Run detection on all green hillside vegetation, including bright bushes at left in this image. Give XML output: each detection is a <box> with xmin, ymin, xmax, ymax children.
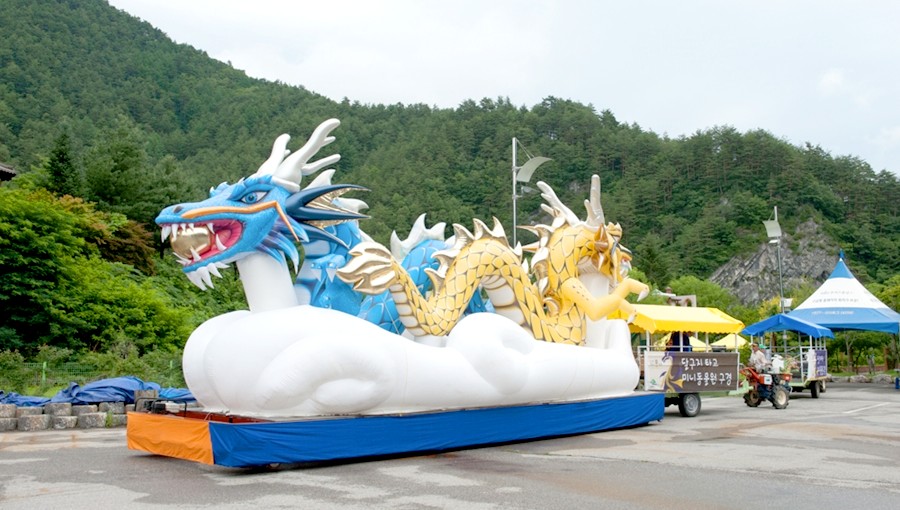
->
<box><xmin>0</xmin><ymin>0</ymin><xmax>900</xmax><ymax>378</ymax></box>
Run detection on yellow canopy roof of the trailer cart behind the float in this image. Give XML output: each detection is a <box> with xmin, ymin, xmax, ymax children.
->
<box><xmin>609</xmin><ymin>304</ymin><xmax>744</xmax><ymax>333</ymax></box>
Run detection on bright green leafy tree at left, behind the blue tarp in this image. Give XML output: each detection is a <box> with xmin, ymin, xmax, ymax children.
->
<box><xmin>0</xmin><ymin>187</ymin><xmax>192</xmax><ymax>354</ymax></box>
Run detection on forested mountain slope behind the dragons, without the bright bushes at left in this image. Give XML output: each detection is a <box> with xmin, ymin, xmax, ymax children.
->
<box><xmin>0</xmin><ymin>0</ymin><xmax>900</xmax><ymax>294</ymax></box>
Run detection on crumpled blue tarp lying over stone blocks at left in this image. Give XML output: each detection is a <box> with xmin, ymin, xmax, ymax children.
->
<box><xmin>0</xmin><ymin>376</ymin><xmax>195</xmax><ymax>407</ymax></box>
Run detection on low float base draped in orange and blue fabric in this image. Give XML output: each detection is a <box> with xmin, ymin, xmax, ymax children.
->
<box><xmin>127</xmin><ymin>393</ymin><xmax>665</xmax><ymax>467</ymax></box>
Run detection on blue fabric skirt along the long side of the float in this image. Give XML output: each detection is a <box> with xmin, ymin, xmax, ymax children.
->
<box><xmin>207</xmin><ymin>393</ymin><xmax>666</xmax><ymax>467</ymax></box>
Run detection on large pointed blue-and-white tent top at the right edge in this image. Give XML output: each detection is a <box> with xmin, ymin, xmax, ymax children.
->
<box><xmin>788</xmin><ymin>252</ymin><xmax>900</xmax><ymax>335</ymax></box>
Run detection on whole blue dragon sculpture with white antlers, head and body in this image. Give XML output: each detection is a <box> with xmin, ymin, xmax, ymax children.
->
<box><xmin>156</xmin><ymin>119</ymin><xmax>490</xmax><ymax>328</ymax></box>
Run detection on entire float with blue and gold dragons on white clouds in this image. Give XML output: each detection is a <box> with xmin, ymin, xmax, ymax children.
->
<box><xmin>127</xmin><ymin>119</ymin><xmax>664</xmax><ymax>467</ymax></box>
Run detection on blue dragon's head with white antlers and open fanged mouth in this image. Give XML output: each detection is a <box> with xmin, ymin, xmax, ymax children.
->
<box><xmin>156</xmin><ymin>119</ymin><xmax>365</xmax><ymax>290</ymax></box>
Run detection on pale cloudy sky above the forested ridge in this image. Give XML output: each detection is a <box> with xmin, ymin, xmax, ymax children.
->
<box><xmin>109</xmin><ymin>0</ymin><xmax>900</xmax><ymax>175</ymax></box>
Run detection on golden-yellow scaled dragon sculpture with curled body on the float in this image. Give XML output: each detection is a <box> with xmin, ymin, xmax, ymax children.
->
<box><xmin>337</xmin><ymin>175</ymin><xmax>649</xmax><ymax>345</ymax></box>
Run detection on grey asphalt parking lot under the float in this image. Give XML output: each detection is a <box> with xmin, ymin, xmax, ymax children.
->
<box><xmin>0</xmin><ymin>383</ymin><xmax>900</xmax><ymax>510</ymax></box>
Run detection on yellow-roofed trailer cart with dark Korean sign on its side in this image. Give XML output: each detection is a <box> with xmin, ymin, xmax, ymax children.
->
<box><xmin>620</xmin><ymin>304</ymin><xmax>744</xmax><ymax>417</ymax></box>
